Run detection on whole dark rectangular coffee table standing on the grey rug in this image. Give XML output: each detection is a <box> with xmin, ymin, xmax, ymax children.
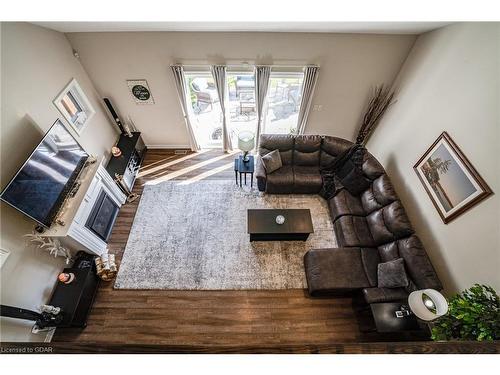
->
<box><xmin>248</xmin><ymin>209</ymin><xmax>314</xmax><ymax>242</ymax></box>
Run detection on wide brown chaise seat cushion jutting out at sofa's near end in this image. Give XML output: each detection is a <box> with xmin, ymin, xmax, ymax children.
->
<box><xmin>304</xmin><ymin>248</ymin><xmax>370</xmax><ymax>296</ymax></box>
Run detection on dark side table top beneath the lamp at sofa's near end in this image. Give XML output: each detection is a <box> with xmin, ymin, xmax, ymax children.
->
<box><xmin>370</xmin><ymin>301</ymin><xmax>422</xmax><ymax>332</ymax></box>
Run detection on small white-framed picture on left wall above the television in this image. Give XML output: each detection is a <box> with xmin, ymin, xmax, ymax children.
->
<box><xmin>53</xmin><ymin>79</ymin><xmax>95</xmax><ymax>134</ymax></box>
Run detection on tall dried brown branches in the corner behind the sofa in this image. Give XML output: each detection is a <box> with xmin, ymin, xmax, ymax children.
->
<box><xmin>356</xmin><ymin>85</ymin><xmax>395</xmax><ymax>146</ymax></box>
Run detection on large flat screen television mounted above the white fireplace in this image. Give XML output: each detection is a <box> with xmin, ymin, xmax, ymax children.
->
<box><xmin>0</xmin><ymin>120</ymin><xmax>89</xmax><ymax>228</ymax></box>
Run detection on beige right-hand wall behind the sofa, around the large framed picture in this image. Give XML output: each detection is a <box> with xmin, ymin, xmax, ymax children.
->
<box><xmin>368</xmin><ymin>23</ymin><xmax>500</xmax><ymax>293</ymax></box>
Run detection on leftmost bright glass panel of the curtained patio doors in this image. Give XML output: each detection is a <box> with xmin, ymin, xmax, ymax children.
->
<box><xmin>184</xmin><ymin>72</ymin><xmax>222</xmax><ymax>148</ymax></box>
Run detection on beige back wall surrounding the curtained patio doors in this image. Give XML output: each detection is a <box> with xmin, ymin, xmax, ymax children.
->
<box><xmin>68</xmin><ymin>32</ymin><xmax>416</xmax><ymax>146</ymax></box>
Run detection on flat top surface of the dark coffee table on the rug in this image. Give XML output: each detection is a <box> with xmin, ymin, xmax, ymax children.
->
<box><xmin>248</xmin><ymin>209</ymin><xmax>314</xmax><ymax>234</ymax></box>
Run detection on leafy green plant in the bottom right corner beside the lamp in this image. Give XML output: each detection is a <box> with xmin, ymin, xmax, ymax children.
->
<box><xmin>432</xmin><ymin>284</ymin><xmax>500</xmax><ymax>341</ymax></box>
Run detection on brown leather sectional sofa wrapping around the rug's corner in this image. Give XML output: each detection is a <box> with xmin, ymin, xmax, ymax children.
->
<box><xmin>256</xmin><ymin>134</ymin><xmax>442</xmax><ymax>303</ymax></box>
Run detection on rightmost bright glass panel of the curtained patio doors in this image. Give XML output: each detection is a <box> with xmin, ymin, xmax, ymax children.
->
<box><xmin>263</xmin><ymin>72</ymin><xmax>304</xmax><ymax>134</ymax></box>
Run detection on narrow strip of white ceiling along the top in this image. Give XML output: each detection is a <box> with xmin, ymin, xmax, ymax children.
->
<box><xmin>33</xmin><ymin>22</ymin><xmax>450</xmax><ymax>34</ymax></box>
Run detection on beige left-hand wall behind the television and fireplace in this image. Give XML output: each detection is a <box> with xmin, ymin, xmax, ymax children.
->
<box><xmin>0</xmin><ymin>22</ymin><xmax>117</xmax><ymax>341</ymax></box>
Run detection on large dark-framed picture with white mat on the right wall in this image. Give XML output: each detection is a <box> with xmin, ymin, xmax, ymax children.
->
<box><xmin>413</xmin><ymin>132</ymin><xmax>493</xmax><ymax>224</ymax></box>
